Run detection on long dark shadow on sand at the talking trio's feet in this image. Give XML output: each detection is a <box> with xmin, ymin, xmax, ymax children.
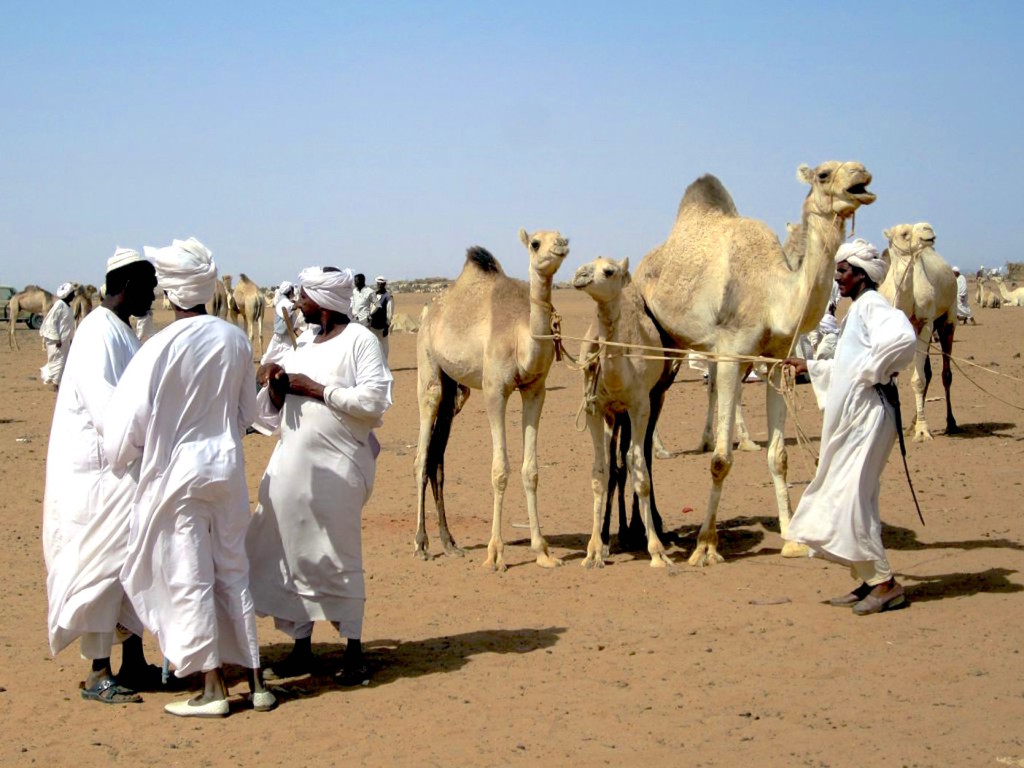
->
<box><xmin>252</xmin><ymin>627</ymin><xmax>565</xmax><ymax>702</ymax></box>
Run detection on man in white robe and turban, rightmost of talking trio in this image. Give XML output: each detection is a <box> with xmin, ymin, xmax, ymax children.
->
<box><xmin>246</xmin><ymin>267</ymin><xmax>392</xmax><ymax>685</ymax></box>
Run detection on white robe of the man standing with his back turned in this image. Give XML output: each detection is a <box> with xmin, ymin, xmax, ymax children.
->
<box><xmin>103</xmin><ymin>315</ymin><xmax>259</xmax><ymax>677</ymax></box>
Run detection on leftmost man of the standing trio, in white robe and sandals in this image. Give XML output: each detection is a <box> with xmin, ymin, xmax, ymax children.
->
<box><xmin>42</xmin><ymin>249</ymin><xmax>160</xmax><ymax>703</ymax></box>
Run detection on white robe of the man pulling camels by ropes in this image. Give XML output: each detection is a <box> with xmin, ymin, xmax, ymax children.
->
<box><xmin>785</xmin><ymin>291</ymin><xmax>915</xmax><ymax>563</ymax></box>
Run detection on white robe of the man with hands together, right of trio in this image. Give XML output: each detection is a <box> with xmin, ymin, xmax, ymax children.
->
<box><xmin>246</xmin><ymin>323</ymin><xmax>392</xmax><ymax>638</ymax></box>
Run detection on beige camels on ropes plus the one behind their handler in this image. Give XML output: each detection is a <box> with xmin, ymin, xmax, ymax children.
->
<box><xmin>415</xmin><ymin>161</ymin><xmax>999</xmax><ymax>570</ymax></box>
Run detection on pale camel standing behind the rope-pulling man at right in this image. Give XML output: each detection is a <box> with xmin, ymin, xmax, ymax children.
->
<box><xmin>879</xmin><ymin>221</ymin><xmax>959</xmax><ymax>442</ymax></box>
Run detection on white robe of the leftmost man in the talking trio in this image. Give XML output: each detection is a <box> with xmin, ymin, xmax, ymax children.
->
<box><xmin>42</xmin><ymin>307</ymin><xmax>142</xmax><ymax>654</ymax></box>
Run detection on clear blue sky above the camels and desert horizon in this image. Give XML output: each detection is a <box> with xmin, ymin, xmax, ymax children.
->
<box><xmin>0</xmin><ymin>1</ymin><xmax>1024</xmax><ymax>288</ymax></box>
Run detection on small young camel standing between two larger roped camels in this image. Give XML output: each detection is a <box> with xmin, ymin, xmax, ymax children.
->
<box><xmin>572</xmin><ymin>258</ymin><xmax>673</xmax><ymax>568</ymax></box>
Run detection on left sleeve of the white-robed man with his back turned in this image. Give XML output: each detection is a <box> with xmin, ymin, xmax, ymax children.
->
<box><xmin>103</xmin><ymin>347</ymin><xmax>154</xmax><ymax>477</ymax></box>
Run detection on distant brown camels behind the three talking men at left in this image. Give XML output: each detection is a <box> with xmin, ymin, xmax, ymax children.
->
<box><xmin>7</xmin><ymin>272</ymin><xmax>266</xmax><ymax>354</ymax></box>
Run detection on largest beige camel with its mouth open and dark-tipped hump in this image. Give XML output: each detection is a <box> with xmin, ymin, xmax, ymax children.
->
<box><xmin>634</xmin><ymin>161</ymin><xmax>874</xmax><ymax>565</ymax></box>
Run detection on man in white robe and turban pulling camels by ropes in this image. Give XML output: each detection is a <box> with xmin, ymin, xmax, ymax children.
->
<box><xmin>784</xmin><ymin>240</ymin><xmax>915</xmax><ymax>615</ymax></box>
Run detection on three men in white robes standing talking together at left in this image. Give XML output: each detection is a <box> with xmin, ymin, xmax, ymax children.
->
<box><xmin>43</xmin><ymin>239</ymin><xmax>392</xmax><ymax>717</ymax></box>
